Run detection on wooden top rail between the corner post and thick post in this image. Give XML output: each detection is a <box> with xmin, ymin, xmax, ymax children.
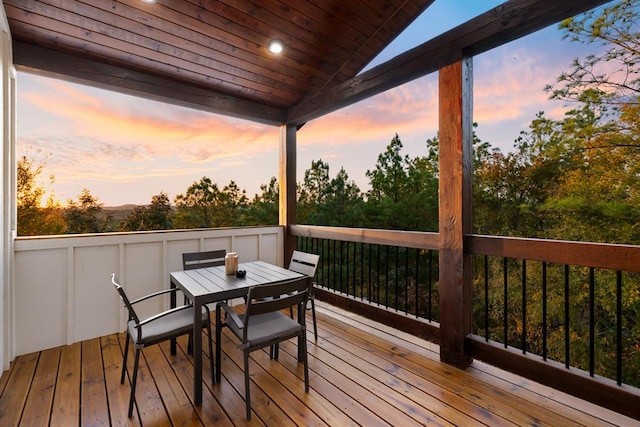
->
<box><xmin>289</xmin><ymin>225</ymin><xmax>439</xmax><ymax>250</ymax></box>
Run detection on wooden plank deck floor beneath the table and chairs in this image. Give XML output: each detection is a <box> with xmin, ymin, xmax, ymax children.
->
<box><xmin>0</xmin><ymin>302</ymin><xmax>640</xmax><ymax>426</ymax></box>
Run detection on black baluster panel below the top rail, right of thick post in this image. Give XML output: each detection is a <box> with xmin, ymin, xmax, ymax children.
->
<box><xmin>474</xmin><ymin>255</ymin><xmax>640</xmax><ymax>387</ymax></box>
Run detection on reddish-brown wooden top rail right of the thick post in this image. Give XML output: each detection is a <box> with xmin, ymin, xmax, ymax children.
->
<box><xmin>466</xmin><ymin>235</ymin><xmax>640</xmax><ymax>273</ymax></box>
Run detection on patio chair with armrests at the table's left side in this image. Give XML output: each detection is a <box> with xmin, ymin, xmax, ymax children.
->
<box><xmin>111</xmin><ymin>274</ymin><xmax>215</xmax><ymax>418</ymax></box>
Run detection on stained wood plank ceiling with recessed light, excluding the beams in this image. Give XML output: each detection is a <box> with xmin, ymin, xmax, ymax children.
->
<box><xmin>4</xmin><ymin>0</ymin><xmax>434</xmax><ymax>123</ymax></box>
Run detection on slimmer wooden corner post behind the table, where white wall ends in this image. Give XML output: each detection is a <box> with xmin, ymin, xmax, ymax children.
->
<box><xmin>279</xmin><ymin>124</ymin><xmax>297</xmax><ymax>264</ymax></box>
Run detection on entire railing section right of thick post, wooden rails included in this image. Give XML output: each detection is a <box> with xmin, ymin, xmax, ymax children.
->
<box><xmin>467</xmin><ymin>235</ymin><xmax>640</xmax><ymax>417</ymax></box>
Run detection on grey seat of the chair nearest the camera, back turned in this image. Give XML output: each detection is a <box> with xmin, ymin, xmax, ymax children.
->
<box><xmin>229</xmin><ymin>311</ymin><xmax>302</xmax><ymax>347</ymax></box>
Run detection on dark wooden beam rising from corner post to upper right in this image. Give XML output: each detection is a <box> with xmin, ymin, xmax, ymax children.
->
<box><xmin>287</xmin><ymin>0</ymin><xmax>610</xmax><ymax>125</ymax></box>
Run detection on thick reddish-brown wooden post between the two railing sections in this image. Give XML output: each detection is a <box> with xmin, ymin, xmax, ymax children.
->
<box><xmin>438</xmin><ymin>58</ymin><xmax>473</xmax><ymax>368</ymax></box>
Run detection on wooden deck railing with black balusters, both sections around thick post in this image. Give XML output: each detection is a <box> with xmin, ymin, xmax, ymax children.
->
<box><xmin>293</xmin><ymin>226</ymin><xmax>640</xmax><ymax>416</ymax></box>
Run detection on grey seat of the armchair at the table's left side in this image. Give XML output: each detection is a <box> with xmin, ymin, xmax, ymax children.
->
<box><xmin>128</xmin><ymin>307</ymin><xmax>208</xmax><ymax>346</ymax></box>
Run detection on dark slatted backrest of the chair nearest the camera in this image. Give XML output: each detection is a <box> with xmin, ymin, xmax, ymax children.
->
<box><xmin>245</xmin><ymin>276</ymin><xmax>313</xmax><ymax>322</ymax></box>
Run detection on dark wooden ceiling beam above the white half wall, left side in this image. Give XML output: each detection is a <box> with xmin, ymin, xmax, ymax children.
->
<box><xmin>13</xmin><ymin>40</ymin><xmax>286</xmax><ymax>126</ymax></box>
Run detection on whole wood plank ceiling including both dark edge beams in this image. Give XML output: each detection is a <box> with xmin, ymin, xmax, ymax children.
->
<box><xmin>3</xmin><ymin>0</ymin><xmax>609</xmax><ymax>125</ymax></box>
